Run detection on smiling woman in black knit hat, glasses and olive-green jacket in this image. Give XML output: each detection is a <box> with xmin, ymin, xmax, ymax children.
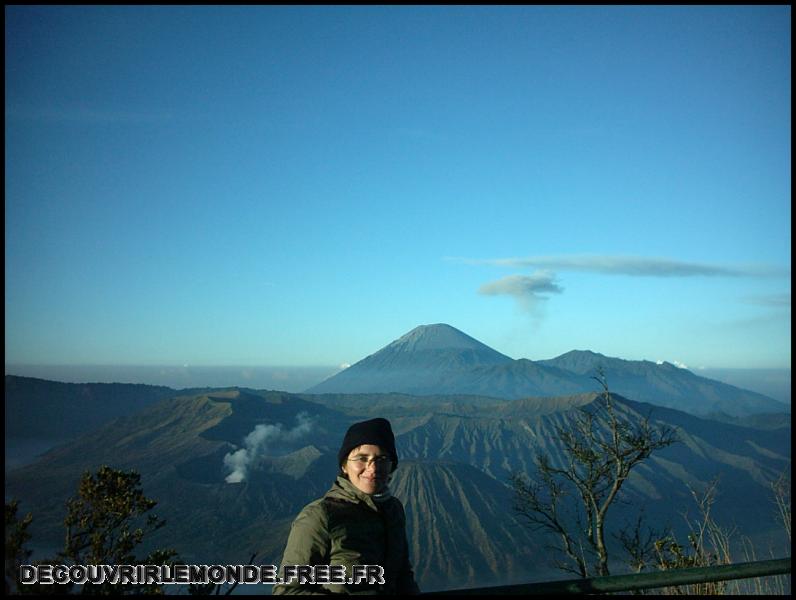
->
<box><xmin>273</xmin><ymin>419</ymin><xmax>420</xmax><ymax>595</ymax></box>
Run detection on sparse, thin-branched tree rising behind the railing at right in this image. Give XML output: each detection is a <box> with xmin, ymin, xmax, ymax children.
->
<box><xmin>510</xmin><ymin>369</ymin><xmax>678</xmax><ymax>577</ymax></box>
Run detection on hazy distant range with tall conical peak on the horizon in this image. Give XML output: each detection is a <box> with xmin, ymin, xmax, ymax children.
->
<box><xmin>307</xmin><ymin>324</ymin><xmax>790</xmax><ymax>417</ymax></box>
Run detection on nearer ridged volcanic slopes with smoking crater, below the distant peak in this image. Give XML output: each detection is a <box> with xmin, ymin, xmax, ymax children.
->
<box><xmin>5</xmin><ymin>389</ymin><xmax>790</xmax><ymax>590</ymax></box>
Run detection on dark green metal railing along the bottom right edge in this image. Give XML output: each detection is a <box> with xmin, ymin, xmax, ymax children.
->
<box><xmin>421</xmin><ymin>558</ymin><xmax>791</xmax><ymax>596</ymax></box>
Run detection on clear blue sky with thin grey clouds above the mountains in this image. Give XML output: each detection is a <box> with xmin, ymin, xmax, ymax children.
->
<box><xmin>5</xmin><ymin>6</ymin><xmax>791</xmax><ymax>372</ymax></box>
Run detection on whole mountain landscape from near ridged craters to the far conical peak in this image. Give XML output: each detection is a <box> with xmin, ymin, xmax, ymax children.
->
<box><xmin>5</xmin><ymin>325</ymin><xmax>791</xmax><ymax>591</ymax></box>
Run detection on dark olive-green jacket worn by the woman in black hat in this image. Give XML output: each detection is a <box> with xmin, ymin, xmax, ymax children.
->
<box><xmin>273</xmin><ymin>476</ymin><xmax>419</xmax><ymax>594</ymax></box>
